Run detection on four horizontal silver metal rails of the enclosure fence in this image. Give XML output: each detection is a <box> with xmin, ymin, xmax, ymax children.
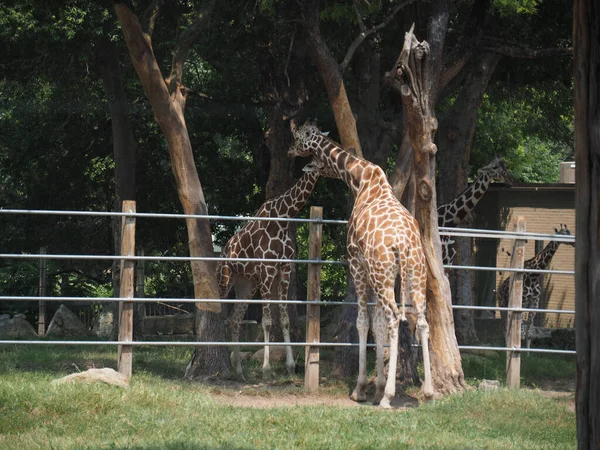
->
<box><xmin>0</xmin><ymin>209</ymin><xmax>576</xmax><ymax>386</ymax></box>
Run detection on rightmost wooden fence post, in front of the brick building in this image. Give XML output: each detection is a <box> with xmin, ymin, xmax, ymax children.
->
<box><xmin>506</xmin><ymin>216</ymin><xmax>525</xmax><ymax>389</ymax></box>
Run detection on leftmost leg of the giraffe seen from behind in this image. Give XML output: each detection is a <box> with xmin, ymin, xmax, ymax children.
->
<box><xmin>350</xmin><ymin>261</ymin><xmax>369</xmax><ymax>402</ymax></box>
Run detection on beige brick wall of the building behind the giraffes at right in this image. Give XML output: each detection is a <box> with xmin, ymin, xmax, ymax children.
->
<box><xmin>496</xmin><ymin>207</ymin><xmax>575</xmax><ymax>327</ymax></box>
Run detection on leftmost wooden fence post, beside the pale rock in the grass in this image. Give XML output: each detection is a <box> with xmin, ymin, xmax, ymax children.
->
<box><xmin>117</xmin><ymin>200</ymin><xmax>135</xmax><ymax>378</ymax></box>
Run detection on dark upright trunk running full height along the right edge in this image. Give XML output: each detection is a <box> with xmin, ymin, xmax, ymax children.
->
<box><xmin>573</xmin><ymin>0</ymin><xmax>600</xmax><ymax>450</ymax></box>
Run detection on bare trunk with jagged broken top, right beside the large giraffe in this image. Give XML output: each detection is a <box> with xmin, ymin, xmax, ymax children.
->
<box><xmin>396</xmin><ymin>26</ymin><xmax>465</xmax><ymax>394</ymax></box>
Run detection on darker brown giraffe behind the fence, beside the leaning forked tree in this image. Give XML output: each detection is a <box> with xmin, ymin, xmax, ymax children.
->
<box><xmin>217</xmin><ymin>161</ymin><xmax>330</xmax><ymax>379</ymax></box>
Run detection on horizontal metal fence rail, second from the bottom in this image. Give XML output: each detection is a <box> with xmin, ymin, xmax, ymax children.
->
<box><xmin>0</xmin><ymin>295</ymin><xmax>575</xmax><ymax>314</ymax></box>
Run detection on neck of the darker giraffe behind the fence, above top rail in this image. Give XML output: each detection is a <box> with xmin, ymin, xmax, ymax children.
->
<box><xmin>257</xmin><ymin>170</ymin><xmax>320</xmax><ymax>217</ymax></box>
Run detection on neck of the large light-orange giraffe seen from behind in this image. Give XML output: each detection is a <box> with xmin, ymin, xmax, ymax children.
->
<box><xmin>313</xmin><ymin>136</ymin><xmax>380</xmax><ymax>198</ymax></box>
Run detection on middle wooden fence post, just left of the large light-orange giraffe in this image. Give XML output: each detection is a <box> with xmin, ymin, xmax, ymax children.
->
<box><xmin>304</xmin><ymin>206</ymin><xmax>323</xmax><ymax>392</ymax></box>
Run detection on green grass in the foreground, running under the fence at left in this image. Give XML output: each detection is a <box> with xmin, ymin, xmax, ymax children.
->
<box><xmin>0</xmin><ymin>346</ymin><xmax>576</xmax><ymax>449</ymax></box>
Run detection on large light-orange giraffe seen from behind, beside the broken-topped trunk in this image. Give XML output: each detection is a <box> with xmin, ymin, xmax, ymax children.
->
<box><xmin>288</xmin><ymin>121</ymin><xmax>433</xmax><ymax>408</ymax></box>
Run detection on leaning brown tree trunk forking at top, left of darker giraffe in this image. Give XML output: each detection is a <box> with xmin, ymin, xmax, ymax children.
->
<box><xmin>114</xmin><ymin>0</ymin><xmax>231</xmax><ymax>378</ymax></box>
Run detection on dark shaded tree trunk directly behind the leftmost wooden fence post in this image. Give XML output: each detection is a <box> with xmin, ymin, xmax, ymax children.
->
<box><xmin>96</xmin><ymin>34</ymin><xmax>137</xmax><ymax>338</ymax></box>
